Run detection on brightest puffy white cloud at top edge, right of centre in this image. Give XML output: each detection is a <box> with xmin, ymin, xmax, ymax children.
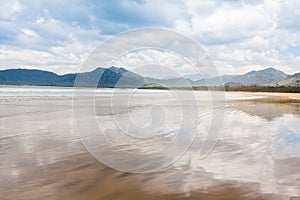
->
<box><xmin>175</xmin><ymin>1</ymin><xmax>276</xmax><ymax>43</ymax></box>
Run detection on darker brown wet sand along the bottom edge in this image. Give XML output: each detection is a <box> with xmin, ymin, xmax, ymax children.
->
<box><xmin>1</xmin><ymin>148</ymin><xmax>287</xmax><ymax>200</ymax></box>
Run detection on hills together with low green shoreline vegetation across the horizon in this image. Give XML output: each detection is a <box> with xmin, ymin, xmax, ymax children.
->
<box><xmin>0</xmin><ymin>67</ymin><xmax>300</xmax><ymax>93</ymax></box>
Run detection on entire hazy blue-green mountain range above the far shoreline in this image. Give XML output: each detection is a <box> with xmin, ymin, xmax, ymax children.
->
<box><xmin>0</xmin><ymin>66</ymin><xmax>300</xmax><ymax>87</ymax></box>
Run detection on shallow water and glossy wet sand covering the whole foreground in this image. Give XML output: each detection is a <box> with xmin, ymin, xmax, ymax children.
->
<box><xmin>0</xmin><ymin>87</ymin><xmax>300</xmax><ymax>199</ymax></box>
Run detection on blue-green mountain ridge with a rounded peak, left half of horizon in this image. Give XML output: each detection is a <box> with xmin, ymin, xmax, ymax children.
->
<box><xmin>0</xmin><ymin>67</ymin><xmax>148</xmax><ymax>87</ymax></box>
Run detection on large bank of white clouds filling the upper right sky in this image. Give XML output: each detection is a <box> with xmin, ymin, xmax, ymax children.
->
<box><xmin>174</xmin><ymin>0</ymin><xmax>300</xmax><ymax>74</ymax></box>
